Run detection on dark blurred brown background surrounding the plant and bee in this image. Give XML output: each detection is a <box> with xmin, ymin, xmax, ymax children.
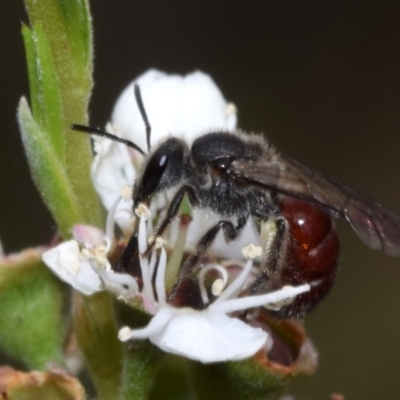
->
<box><xmin>0</xmin><ymin>0</ymin><xmax>400</xmax><ymax>400</ymax></box>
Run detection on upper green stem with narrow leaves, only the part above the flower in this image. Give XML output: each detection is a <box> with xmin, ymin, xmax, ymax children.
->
<box><xmin>20</xmin><ymin>0</ymin><xmax>103</xmax><ymax>237</ymax></box>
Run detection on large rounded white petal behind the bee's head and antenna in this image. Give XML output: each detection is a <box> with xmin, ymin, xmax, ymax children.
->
<box><xmin>112</xmin><ymin>69</ymin><xmax>236</xmax><ymax>152</ymax></box>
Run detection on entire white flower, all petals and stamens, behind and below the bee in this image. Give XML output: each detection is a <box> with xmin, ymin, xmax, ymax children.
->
<box><xmin>43</xmin><ymin>70</ymin><xmax>310</xmax><ymax>363</ymax></box>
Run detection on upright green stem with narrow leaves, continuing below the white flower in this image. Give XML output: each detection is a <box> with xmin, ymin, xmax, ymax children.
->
<box><xmin>18</xmin><ymin>0</ymin><xmax>122</xmax><ymax>400</ymax></box>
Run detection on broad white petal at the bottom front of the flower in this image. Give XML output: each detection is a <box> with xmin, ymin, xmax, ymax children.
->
<box><xmin>149</xmin><ymin>311</ymin><xmax>268</xmax><ymax>363</ymax></box>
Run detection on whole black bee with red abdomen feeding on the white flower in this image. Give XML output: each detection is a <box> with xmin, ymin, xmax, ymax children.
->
<box><xmin>72</xmin><ymin>85</ymin><xmax>400</xmax><ymax>318</ymax></box>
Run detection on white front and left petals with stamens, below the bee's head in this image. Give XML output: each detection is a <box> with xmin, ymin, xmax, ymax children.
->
<box><xmin>43</xmin><ymin>205</ymin><xmax>310</xmax><ymax>363</ymax></box>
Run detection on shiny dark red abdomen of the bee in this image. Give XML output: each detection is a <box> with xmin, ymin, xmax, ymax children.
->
<box><xmin>276</xmin><ymin>198</ymin><xmax>339</xmax><ymax>318</ymax></box>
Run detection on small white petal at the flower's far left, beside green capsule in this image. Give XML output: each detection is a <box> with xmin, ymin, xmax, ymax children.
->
<box><xmin>43</xmin><ymin>240</ymin><xmax>102</xmax><ymax>296</ymax></box>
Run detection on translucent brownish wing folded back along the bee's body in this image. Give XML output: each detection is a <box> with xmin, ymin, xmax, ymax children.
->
<box><xmin>232</xmin><ymin>155</ymin><xmax>400</xmax><ymax>257</ymax></box>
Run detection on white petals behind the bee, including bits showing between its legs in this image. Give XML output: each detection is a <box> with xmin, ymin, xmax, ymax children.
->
<box><xmin>92</xmin><ymin>70</ymin><xmax>260</xmax><ymax>259</ymax></box>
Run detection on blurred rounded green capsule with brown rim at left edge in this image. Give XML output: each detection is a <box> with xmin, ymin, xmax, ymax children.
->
<box><xmin>0</xmin><ymin>249</ymin><xmax>68</xmax><ymax>369</ymax></box>
